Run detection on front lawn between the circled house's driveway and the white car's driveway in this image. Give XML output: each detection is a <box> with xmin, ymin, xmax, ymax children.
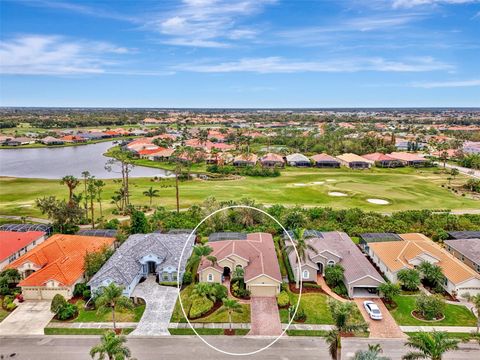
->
<box><xmin>280</xmin><ymin>292</ymin><xmax>363</xmax><ymax>325</ymax></box>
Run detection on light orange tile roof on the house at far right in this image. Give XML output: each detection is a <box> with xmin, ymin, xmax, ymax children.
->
<box><xmin>368</xmin><ymin>234</ymin><xmax>480</xmax><ymax>284</ymax></box>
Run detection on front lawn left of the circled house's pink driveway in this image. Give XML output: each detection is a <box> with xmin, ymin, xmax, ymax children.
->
<box><xmin>170</xmin><ymin>285</ymin><xmax>250</xmax><ymax>323</ymax></box>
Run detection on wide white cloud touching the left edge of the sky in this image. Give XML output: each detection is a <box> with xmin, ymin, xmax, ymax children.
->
<box><xmin>0</xmin><ymin>35</ymin><xmax>128</xmax><ymax>75</ymax></box>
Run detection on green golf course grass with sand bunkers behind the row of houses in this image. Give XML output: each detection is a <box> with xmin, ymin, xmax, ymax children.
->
<box><xmin>0</xmin><ymin>168</ymin><xmax>479</xmax><ymax>217</ymax></box>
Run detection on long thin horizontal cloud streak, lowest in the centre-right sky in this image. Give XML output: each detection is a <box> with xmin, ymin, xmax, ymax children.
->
<box><xmin>175</xmin><ymin>56</ymin><xmax>453</xmax><ymax>74</ymax></box>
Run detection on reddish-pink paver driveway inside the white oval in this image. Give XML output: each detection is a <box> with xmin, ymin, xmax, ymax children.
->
<box><xmin>248</xmin><ymin>296</ymin><xmax>282</xmax><ymax>336</ymax></box>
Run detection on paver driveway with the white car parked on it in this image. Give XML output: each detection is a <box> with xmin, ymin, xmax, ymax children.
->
<box><xmin>354</xmin><ymin>298</ymin><xmax>406</xmax><ymax>339</ymax></box>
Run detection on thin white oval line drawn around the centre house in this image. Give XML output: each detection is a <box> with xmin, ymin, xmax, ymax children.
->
<box><xmin>177</xmin><ymin>205</ymin><xmax>303</xmax><ymax>356</ymax></box>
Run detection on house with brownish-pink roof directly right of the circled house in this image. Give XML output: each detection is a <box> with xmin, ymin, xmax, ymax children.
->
<box><xmin>285</xmin><ymin>231</ymin><xmax>385</xmax><ymax>298</ymax></box>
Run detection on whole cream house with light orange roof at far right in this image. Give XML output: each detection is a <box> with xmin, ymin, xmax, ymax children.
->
<box><xmin>368</xmin><ymin>233</ymin><xmax>480</xmax><ymax>296</ymax></box>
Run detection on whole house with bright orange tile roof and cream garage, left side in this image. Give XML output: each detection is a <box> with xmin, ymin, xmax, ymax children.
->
<box><xmin>8</xmin><ymin>234</ymin><xmax>115</xmax><ymax>300</ymax></box>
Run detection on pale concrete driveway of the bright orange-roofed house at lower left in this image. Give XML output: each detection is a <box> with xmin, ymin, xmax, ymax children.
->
<box><xmin>0</xmin><ymin>300</ymin><xmax>54</xmax><ymax>335</ymax></box>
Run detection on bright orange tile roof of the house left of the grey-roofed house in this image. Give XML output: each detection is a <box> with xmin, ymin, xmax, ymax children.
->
<box><xmin>8</xmin><ymin>234</ymin><xmax>115</xmax><ymax>286</ymax></box>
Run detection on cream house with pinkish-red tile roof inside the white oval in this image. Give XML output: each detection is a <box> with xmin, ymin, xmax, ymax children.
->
<box><xmin>198</xmin><ymin>233</ymin><xmax>282</xmax><ymax>297</ymax></box>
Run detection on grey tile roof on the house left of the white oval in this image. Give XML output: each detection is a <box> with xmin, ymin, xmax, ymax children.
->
<box><xmin>88</xmin><ymin>233</ymin><xmax>194</xmax><ymax>287</ymax></box>
